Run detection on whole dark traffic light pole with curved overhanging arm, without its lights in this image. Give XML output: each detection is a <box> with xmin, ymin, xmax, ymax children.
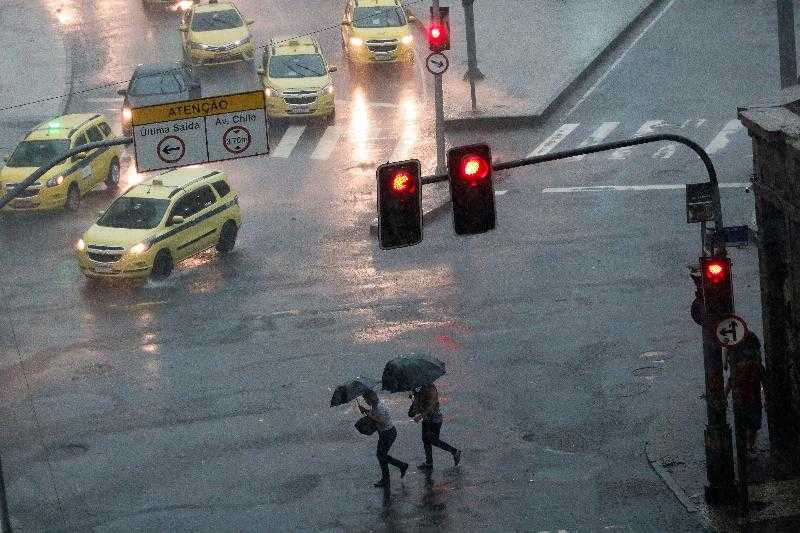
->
<box><xmin>421</xmin><ymin>133</ymin><xmax>745</xmax><ymax>505</ymax></box>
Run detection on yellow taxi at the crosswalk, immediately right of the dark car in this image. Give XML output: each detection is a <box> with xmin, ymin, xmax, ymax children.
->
<box><xmin>258</xmin><ymin>37</ymin><xmax>336</xmax><ymax>123</ymax></box>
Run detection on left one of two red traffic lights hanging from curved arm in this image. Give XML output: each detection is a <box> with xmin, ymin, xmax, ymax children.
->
<box><xmin>376</xmin><ymin>159</ymin><xmax>422</xmax><ymax>250</ymax></box>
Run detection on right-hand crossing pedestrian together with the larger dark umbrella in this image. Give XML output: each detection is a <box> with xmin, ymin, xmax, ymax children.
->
<box><xmin>381</xmin><ymin>356</ymin><xmax>461</xmax><ymax>469</ymax></box>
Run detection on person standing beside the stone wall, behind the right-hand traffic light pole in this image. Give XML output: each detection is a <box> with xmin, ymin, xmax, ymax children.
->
<box><xmin>725</xmin><ymin>332</ymin><xmax>766</xmax><ymax>452</ymax></box>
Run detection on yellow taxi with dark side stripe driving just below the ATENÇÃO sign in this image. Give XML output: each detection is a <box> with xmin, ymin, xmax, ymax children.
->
<box><xmin>76</xmin><ymin>168</ymin><xmax>242</xmax><ymax>279</ymax></box>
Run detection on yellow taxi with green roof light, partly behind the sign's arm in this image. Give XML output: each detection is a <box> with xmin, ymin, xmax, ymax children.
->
<box><xmin>0</xmin><ymin>113</ymin><xmax>122</xmax><ymax>211</ymax></box>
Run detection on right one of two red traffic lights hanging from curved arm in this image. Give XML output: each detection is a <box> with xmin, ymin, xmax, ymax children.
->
<box><xmin>447</xmin><ymin>144</ymin><xmax>495</xmax><ymax>235</ymax></box>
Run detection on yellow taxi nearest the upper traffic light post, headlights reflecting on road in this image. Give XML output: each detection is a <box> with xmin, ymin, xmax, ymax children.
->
<box><xmin>342</xmin><ymin>0</ymin><xmax>415</xmax><ymax>63</ymax></box>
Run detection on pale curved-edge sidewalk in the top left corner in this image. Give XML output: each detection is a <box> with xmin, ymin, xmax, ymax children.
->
<box><xmin>0</xmin><ymin>0</ymin><xmax>70</xmax><ymax>156</ymax></box>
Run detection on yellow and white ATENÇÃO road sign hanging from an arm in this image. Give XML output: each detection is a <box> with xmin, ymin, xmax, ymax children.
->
<box><xmin>131</xmin><ymin>91</ymin><xmax>269</xmax><ymax>172</ymax></box>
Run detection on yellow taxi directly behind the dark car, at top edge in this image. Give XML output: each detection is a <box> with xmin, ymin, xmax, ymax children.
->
<box><xmin>180</xmin><ymin>1</ymin><xmax>255</xmax><ymax>65</ymax></box>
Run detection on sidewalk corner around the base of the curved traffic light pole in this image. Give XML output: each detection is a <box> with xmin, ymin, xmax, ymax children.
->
<box><xmin>647</xmin><ymin>378</ymin><xmax>800</xmax><ymax>532</ymax></box>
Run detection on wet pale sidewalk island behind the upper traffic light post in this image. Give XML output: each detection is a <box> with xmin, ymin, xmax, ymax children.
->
<box><xmin>409</xmin><ymin>0</ymin><xmax>658</xmax><ymax>125</ymax></box>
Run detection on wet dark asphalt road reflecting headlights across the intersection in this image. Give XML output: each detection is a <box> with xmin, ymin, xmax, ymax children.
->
<box><xmin>0</xmin><ymin>0</ymin><xmax>775</xmax><ymax>531</ymax></box>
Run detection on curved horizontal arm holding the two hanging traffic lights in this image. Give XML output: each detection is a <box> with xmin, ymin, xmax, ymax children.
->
<box><xmin>422</xmin><ymin>133</ymin><xmax>724</xmax><ymax>231</ymax></box>
